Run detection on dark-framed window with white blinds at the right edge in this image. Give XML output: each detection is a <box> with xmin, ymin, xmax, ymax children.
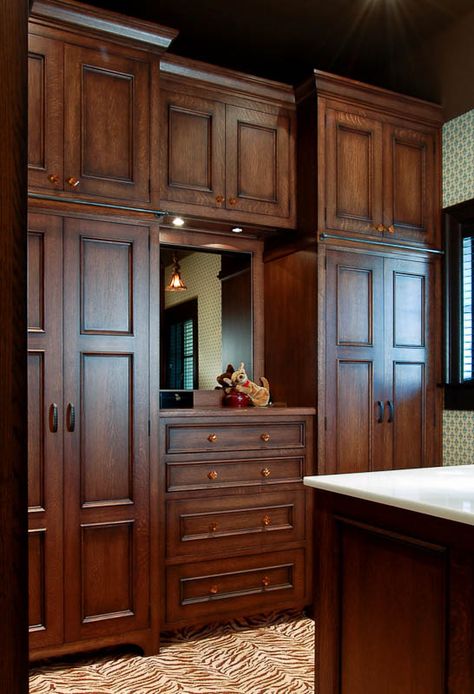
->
<box><xmin>445</xmin><ymin>200</ymin><xmax>474</xmax><ymax>410</ymax></box>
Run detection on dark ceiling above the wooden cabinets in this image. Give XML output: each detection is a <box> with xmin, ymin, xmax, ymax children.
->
<box><xmin>89</xmin><ymin>0</ymin><xmax>474</xmax><ymax>106</ymax></box>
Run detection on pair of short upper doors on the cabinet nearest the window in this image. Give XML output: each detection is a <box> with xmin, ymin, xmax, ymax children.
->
<box><xmin>320</xmin><ymin>102</ymin><xmax>440</xmax><ymax>246</ymax></box>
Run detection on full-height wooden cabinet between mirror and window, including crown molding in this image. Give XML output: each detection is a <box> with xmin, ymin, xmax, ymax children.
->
<box><xmin>265</xmin><ymin>71</ymin><xmax>441</xmax><ymax>473</ymax></box>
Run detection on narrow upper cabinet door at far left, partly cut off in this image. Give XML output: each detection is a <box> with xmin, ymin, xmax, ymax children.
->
<box><xmin>28</xmin><ymin>34</ymin><xmax>63</xmax><ymax>190</ymax></box>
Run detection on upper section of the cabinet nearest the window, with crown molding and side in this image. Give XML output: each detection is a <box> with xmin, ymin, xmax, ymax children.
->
<box><xmin>299</xmin><ymin>70</ymin><xmax>442</xmax><ymax>247</ymax></box>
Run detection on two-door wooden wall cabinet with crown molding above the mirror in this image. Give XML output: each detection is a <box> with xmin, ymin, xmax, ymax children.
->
<box><xmin>160</xmin><ymin>56</ymin><xmax>295</xmax><ymax>227</ymax></box>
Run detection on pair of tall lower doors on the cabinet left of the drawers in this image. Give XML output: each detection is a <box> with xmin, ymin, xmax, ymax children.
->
<box><xmin>28</xmin><ymin>214</ymin><xmax>150</xmax><ymax>649</ymax></box>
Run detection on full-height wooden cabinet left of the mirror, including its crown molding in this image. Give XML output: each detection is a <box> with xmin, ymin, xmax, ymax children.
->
<box><xmin>28</xmin><ymin>0</ymin><xmax>176</xmax><ymax>658</ymax></box>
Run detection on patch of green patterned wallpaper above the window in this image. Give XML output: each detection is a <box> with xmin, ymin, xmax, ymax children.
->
<box><xmin>443</xmin><ymin>109</ymin><xmax>474</xmax><ymax>207</ymax></box>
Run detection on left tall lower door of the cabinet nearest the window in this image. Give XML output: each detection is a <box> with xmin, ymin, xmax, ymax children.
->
<box><xmin>323</xmin><ymin>250</ymin><xmax>384</xmax><ymax>473</ymax></box>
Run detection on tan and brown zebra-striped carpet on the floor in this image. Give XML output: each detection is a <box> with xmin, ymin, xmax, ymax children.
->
<box><xmin>30</xmin><ymin>612</ymin><xmax>314</xmax><ymax>694</ymax></box>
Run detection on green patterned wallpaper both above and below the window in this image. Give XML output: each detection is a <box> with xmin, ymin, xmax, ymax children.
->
<box><xmin>443</xmin><ymin>110</ymin><xmax>474</xmax><ymax>465</ymax></box>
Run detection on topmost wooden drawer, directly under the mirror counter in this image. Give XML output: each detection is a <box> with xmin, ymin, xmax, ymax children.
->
<box><xmin>165</xmin><ymin>421</ymin><xmax>305</xmax><ymax>453</ymax></box>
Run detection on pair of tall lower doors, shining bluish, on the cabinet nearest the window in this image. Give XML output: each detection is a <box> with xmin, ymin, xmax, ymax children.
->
<box><xmin>319</xmin><ymin>249</ymin><xmax>440</xmax><ymax>473</ymax></box>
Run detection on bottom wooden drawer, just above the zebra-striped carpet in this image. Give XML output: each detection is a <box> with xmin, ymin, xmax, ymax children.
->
<box><xmin>166</xmin><ymin>549</ymin><xmax>305</xmax><ymax>626</ymax></box>
